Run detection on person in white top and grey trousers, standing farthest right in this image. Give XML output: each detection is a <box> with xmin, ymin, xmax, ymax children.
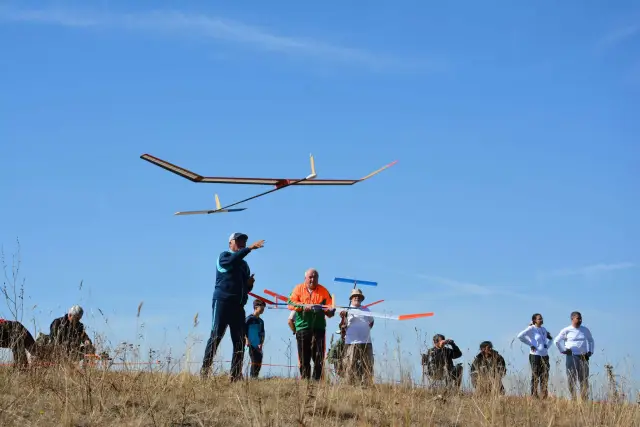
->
<box><xmin>555</xmin><ymin>311</ymin><xmax>595</xmax><ymax>400</ymax></box>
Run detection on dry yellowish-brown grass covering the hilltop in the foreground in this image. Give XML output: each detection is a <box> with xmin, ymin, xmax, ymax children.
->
<box><xmin>0</xmin><ymin>367</ymin><xmax>640</xmax><ymax>426</ymax></box>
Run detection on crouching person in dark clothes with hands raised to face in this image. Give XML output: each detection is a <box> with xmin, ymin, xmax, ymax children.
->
<box><xmin>422</xmin><ymin>334</ymin><xmax>463</xmax><ymax>388</ymax></box>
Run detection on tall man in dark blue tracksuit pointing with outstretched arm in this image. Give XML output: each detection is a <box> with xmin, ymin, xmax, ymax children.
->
<box><xmin>200</xmin><ymin>233</ymin><xmax>264</xmax><ymax>381</ymax></box>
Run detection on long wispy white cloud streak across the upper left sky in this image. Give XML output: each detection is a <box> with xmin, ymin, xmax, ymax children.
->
<box><xmin>0</xmin><ymin>7</ymin><xmax>441</xmax><ymax>70</ymax></box>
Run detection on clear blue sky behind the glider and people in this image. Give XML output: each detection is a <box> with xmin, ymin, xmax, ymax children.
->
<box><xmin>0</xmin><ymin>1</ymin><xmax>640</xmax><ymax>396</ymax></box>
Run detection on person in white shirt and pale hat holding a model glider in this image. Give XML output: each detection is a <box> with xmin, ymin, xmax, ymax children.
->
<box><xmin>340</xmin><ymin>289</ymin><xmax>374</xmax><ymax>384</ymax></box>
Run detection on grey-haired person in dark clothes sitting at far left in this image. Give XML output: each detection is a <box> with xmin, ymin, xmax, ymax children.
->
<box><xmin>49</xmin><ymin>305</ymin><xmax>95</xmax><ymax>361</ymax></box>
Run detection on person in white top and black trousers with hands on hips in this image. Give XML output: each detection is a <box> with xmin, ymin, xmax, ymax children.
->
<box><xmin>518</xmin><ymin>313</ymin><xmax>553</xmax><ymax>399</ymax></box>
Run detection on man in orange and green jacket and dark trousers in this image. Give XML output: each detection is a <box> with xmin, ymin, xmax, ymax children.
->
<box><xmin>288</xmin><ymin>268</ymin><xmax>336</xmax><ymax>381</ymax></box>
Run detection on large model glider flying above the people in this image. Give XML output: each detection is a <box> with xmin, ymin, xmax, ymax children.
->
<box><xmin>140</xmin><ymin>154</ymin><xmax>397</xmax><ymax>215</ymax></box>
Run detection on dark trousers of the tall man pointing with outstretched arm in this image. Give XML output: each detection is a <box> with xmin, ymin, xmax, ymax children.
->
<box><xmin>201</xmin><ymin>300</ymin><xmax>245</xmax><ymax>379</ymax></box>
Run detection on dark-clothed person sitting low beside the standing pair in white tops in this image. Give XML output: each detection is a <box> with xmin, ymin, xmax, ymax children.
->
<box><xmin>471</xmin><ymin>341</ymin><xmax>507</xmax><ymax>394</ymax></box>
